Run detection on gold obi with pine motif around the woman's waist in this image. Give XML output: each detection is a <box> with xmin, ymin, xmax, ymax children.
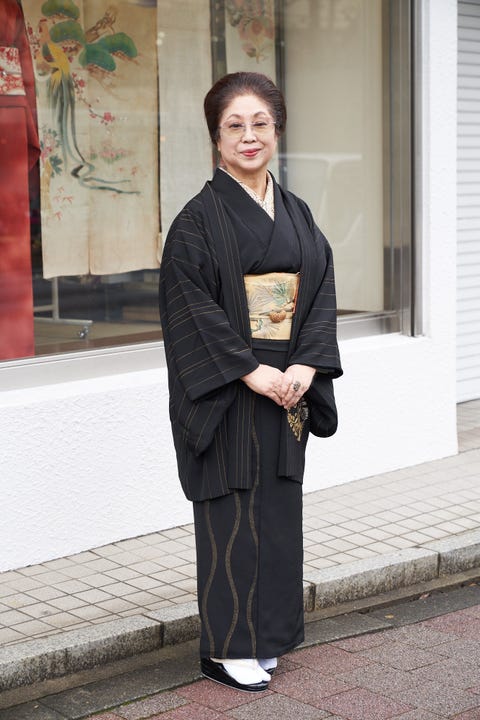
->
<box><xmin>243</xmin><ymin>273</ymin><xmax>300</xmax><ymax>340</ymax></box>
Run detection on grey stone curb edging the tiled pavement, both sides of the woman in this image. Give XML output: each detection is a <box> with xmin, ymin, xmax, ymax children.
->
<box><xmin>0</xmin><ymin>530</ymin><xmax>480</xmax><ymax>692</ymax></box>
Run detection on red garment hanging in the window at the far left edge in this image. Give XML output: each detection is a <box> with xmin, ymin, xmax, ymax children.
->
<box><xmin>0</xmin><ymin>0</ymin><xmax>40</xmax><ymax>360</ymax></box>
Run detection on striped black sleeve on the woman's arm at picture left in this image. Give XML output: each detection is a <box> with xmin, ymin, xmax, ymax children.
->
<box><xmin>160</xmin><ymin>206</ymin><xmax>258</xmax><ymax>402</ymax></box>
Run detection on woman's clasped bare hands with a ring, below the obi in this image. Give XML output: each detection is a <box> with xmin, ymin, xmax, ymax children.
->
<box><xmin>242</xmin><ymin>365</ymin><xmax>315</xmax><ymax>410</ymax></box>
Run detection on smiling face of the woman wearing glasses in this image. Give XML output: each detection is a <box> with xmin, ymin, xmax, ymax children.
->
<box><xmin>217</xmin><ymin>95</ymin><xmax>277</xmax><ymax>181</ymax></box>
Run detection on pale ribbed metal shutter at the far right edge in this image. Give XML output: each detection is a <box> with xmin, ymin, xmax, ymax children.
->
<box><xmin>457</xmin><ymin>0</ymin><xmax>480</xmax><ymax>402</ymax></box>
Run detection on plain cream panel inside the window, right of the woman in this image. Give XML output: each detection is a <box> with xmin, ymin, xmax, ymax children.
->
<box><xmin>285</xmin><ymin>0</ymin><xmax>385</xmax><ymax>313</ymax></box>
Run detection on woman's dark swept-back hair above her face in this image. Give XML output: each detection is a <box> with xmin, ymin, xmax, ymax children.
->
<box><xmin>203</xmin><ymin>72</ymin><xmax>287</xmax><ymax>145</ymax></box>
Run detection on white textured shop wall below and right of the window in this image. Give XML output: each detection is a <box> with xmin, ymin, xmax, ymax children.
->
<box><xmin>0</xmin><ymin>0</ymin><xmax>457</xmax><ymax>570</ymax></box>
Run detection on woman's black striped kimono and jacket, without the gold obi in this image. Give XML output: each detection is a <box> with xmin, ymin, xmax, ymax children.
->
<box><xmin>160</xmin><ymin>170</ymin><xmax>342</xmax><ymax>658</ymax></box>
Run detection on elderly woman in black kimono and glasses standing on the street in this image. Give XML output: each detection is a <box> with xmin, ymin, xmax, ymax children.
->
<box><xmin>160</xmin><ymin>72</ymin><xmax>342</xmax><ymax>691</ymax></box>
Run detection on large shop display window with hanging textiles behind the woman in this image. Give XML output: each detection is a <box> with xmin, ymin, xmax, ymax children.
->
<box><xmin>0</xmin><ymin>0</ymin><xmax>411</xmax><ymax>361</ymax></box>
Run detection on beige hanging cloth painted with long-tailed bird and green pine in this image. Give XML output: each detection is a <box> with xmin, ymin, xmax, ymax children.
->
<box><xmin>23</xmin><ymin>0</ymin><xmax>159</xmax><ymax>277</ymax></box>
